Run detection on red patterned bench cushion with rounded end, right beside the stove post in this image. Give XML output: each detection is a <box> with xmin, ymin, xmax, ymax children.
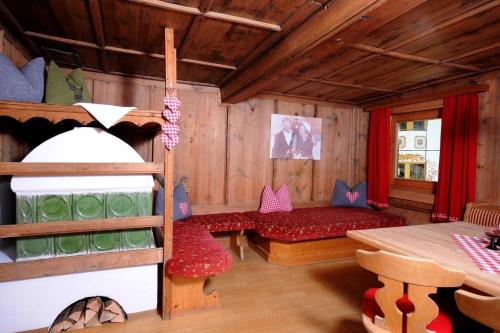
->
<box><xmin>167</xmin><ymin>222</ymin><xmax>233</xmax><ymax>277</ymax></box>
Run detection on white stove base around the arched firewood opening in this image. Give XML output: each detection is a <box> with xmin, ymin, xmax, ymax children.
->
<box><xmin>0</xmin><ymin>265</ymin><xmax>158</xmax><ymax>333</ymax></box>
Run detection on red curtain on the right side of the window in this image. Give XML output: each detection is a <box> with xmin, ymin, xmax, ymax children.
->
<box><xmin>432</xmin><ymin>93</ymin><xmax>478</xmax><ymax>221</ymax></box>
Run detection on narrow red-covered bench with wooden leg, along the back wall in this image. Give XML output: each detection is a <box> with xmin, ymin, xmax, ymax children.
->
<box><xmin>183</xmin><ymin>212</ymin><xmax>255</xmax><ymax>260</ymax></box>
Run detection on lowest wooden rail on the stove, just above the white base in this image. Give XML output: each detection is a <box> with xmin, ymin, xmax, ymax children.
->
<box><xmin>0</xmin><ymin>247</ymin><xmax>163</xmax><ymax>282</ymax></box>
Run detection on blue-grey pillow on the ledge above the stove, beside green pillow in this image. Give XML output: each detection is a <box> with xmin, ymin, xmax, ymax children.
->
<box><xmin>0</xmin><ymin>53</ymin><xmax>45</xmax><ymax>103</ymax></box>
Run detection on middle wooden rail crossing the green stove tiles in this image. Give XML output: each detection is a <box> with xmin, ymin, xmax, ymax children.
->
<box><xmin>0</xmin><ymin>216</ymin><xmax>163</xmax><ymax>238</ymax></box>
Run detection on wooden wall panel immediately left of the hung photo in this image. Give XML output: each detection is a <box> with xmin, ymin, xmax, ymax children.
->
<box><xmin>227</xmin><ymin>100</ymin><xmax>275</xmax><ymax>205</ymax></box>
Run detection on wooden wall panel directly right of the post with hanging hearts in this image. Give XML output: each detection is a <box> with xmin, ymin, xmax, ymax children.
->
<box><xmin>174</xmin><ymin>90</ymin><xmax>227</xmax><ymax>204</ymax></box>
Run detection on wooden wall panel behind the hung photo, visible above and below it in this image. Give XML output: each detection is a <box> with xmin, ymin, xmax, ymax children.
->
<box><xmin>274</xmin><ymin>100</ymin><xmax>316</xmax><ymax>201</ymax></box>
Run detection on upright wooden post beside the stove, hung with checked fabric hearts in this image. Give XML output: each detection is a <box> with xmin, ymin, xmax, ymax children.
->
<box><xmin>162</xmin><ymin>28</ymin><xmax>177</xmax><ymax>320</ymax></box>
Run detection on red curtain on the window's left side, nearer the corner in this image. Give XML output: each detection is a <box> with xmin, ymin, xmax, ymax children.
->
<box><xmin>367</xmin><ymin>107</ymin><xmax>391</xmax><ymax>208</ymax></box>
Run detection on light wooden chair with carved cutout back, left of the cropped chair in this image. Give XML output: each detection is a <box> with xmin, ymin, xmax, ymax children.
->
<box><xmin>356</xmin><ymin>249</ymin><xmax>465</xmax><ymax>333</ymax></box>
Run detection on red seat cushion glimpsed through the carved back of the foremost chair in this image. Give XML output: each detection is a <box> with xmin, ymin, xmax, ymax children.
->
<box><xmin>363</xmin><ymin>288</ymin><xmax>453</xmax><ymax>333</ymax></box>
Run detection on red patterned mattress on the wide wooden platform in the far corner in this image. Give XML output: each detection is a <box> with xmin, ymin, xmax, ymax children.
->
<box><xmin>246</xmin><ymin>207</ymin><xmax>406</xmax><ymax>242</ymax></box>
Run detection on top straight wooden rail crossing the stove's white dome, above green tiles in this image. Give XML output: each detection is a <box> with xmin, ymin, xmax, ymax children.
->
<box><xmin>0</xmin><ymin>162</ymin><xmax>164</xmax><ymax>176</ymax></box>
